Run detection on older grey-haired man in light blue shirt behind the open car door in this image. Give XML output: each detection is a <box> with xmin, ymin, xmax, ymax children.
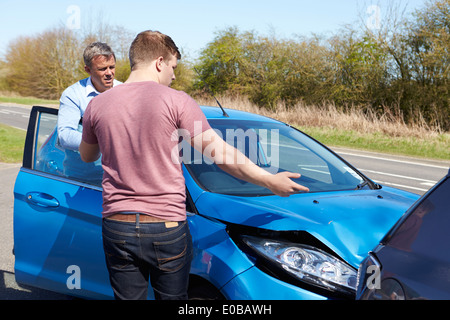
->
<box><xmin>58</xmin><ymin>42</ymin><xmax>120</xmax><ymax>182</ymax></box>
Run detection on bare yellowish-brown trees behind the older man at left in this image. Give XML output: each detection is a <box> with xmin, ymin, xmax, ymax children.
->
<box><xmin>5</xmin><ymin>24</ymin><xmax>132</xmax><ymax>99</ymax></box>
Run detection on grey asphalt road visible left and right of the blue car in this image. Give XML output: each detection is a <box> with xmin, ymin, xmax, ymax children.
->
<box><xmin>0</xmin><ymin>105</ymin><xmax>450</xmax><ymax>300</ymax></box>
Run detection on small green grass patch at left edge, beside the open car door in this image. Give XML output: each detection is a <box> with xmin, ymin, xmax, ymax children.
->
<box><xmin>0</xmin><ymin>124</ymin><xmax>26</xmax><ymax>163</ymax></box>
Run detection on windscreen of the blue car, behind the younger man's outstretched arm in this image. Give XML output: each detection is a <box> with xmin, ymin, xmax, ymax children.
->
<box><xmin>183</xmin><ymin>119</ymin><xmax>364</xmax><ymax>196</ymax></box>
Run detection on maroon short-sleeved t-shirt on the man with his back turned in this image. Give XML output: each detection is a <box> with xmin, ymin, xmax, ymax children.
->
<box><xmin>82</xmin><ymin>81</ymin><xmax>211</xmax><ymax>221</ymax></box>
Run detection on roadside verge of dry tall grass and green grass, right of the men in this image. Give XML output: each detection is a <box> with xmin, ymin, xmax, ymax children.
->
<box><xmin>198</xmin><ymin>93</ymin><xmax>450</xmax><ymax>161</ymax></box>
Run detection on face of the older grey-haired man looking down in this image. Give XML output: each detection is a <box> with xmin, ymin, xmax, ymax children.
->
<box><xmin>84</xmin><ymin>56</ymin><xmax>116</xmax><ymax>92</ymax></box>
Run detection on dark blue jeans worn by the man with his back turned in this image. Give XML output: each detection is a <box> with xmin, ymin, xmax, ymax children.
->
<box><xmin>102</xmin><ymin>215</ymin><xmax>192</xmax><ymax>300</ymax></box>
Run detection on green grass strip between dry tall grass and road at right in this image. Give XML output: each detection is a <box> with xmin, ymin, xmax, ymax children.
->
<box><xmin>299</xmin><ymin>127</ymin><xmax>450</xmax><ymax>161</ymax></box>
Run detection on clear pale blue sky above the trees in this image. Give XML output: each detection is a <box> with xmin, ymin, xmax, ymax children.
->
<box><xmin>0</xmin><ymin>0</ymin><xmax>426</xmax><ymax>57</ymax></box>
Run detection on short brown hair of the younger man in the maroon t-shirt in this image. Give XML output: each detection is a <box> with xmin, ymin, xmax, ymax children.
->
<box><xmin>130</xmin><ymin>30</ymin><xmax>181</xmax><ymax>70</ymax></box>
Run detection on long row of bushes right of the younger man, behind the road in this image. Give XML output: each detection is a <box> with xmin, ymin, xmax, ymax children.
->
<box><xmin>192</xmin><ymin>0</ymin><xmax>450</xmax><ymax>131</ymax></box>
